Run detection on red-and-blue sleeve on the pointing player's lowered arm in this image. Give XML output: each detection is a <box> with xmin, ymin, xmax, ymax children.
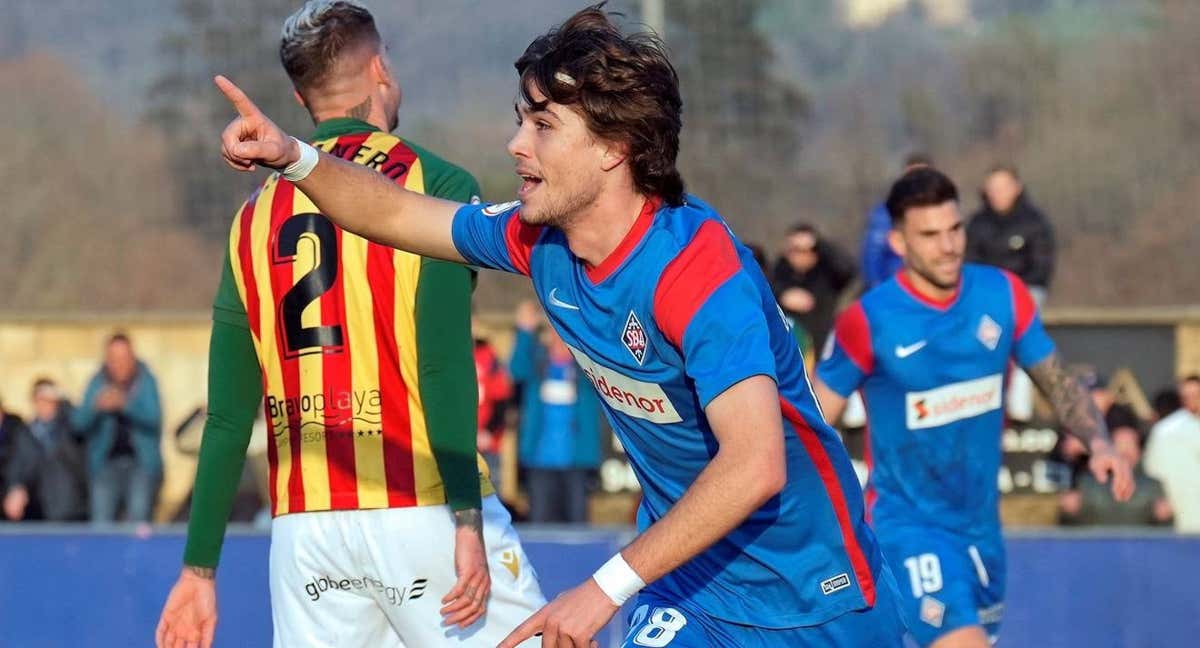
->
<box><xmin>654</xmin><ymin>221</ymin><xmax>776</xmax><ymax>407</ymax></box>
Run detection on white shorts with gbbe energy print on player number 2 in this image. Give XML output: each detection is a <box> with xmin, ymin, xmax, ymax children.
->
<box><xmin>270</xmin><ymin>496</ymin><xmax>546</xmax><ymax>648</ymax></box>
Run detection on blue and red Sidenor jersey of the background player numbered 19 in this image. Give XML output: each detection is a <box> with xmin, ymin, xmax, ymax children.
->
<box><xmin>817</xmin><ymin>264</ymin><xmax>1055</xmax><ymax>535</ymax></box>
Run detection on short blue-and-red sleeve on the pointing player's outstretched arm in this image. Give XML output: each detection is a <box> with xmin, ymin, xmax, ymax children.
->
<box><xmin>451</xmin><ymin>203</ymin><xmax>542</xmax><ymax>276</ymax></box>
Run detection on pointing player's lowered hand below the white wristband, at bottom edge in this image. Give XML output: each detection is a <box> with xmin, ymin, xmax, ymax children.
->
<box><xmin>499</xmin><ymin>578</ymin><xmax>620</xmax><ymax>648</ymax></box>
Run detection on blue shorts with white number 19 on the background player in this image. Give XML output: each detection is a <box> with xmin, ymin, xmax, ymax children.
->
<box><xmin>876</xmin><ymin>526</ymin><xmax>1004</xmax><ymax>646</ymax></box>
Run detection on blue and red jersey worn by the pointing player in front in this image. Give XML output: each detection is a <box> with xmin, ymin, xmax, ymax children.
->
<box><xmin>454</xmin><ymin>197</ymin><xmax>882</xmax><ymax>628</ymax></box>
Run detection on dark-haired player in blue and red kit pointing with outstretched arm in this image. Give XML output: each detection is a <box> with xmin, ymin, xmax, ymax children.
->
<box><xmin>217</xmin><ymin>2</ymin><xmax>905</xmax><ymax>648</ymax></box>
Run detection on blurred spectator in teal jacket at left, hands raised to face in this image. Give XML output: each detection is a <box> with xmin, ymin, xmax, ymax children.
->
<box><xmin>72</xmin><ymin>334</ymin><xmax>162</xmax><ymax>522</ymax></box>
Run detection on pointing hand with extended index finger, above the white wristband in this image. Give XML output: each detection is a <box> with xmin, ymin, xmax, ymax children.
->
<box><xmin>212</xmin><ymin>76</ymin><xmax>300</xmax><ymax>170</ymax></box>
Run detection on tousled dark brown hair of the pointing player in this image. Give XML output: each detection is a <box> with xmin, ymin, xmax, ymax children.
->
<box><xmin>516</xmin><ymin>2</ymin><xmax>684</xmax><ymax>205</ymax></box>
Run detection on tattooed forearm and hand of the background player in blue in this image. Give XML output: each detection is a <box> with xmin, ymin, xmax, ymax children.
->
<box><xmin>1028</xmin><ymin>353</ymin><xmax>1134</xmax><ymax>502</ymax></box>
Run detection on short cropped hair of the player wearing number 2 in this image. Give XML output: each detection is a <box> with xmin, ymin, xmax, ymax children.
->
<box><xmin>280</xmin><ymin>0</ymin><xmax>382</xmax><ymax>92</ymax></box>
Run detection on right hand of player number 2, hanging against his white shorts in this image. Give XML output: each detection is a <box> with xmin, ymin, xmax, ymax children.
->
<box><xmin>442</xmin><ymin>509</ymin><xmax>492</xmax><ymax>628</ymax></box>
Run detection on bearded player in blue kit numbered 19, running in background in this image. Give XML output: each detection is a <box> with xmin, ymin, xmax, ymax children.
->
<box><xmin>816</xmin><ymin>167</ymin><xmax>1133</xmax><ymax>648</ymax></box>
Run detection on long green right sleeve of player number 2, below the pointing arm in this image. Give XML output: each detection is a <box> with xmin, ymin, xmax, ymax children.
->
<box><xmin>416</xmin><ymin>259</ymin><xmax>481</xmax><ymax>511</ymax></box>
